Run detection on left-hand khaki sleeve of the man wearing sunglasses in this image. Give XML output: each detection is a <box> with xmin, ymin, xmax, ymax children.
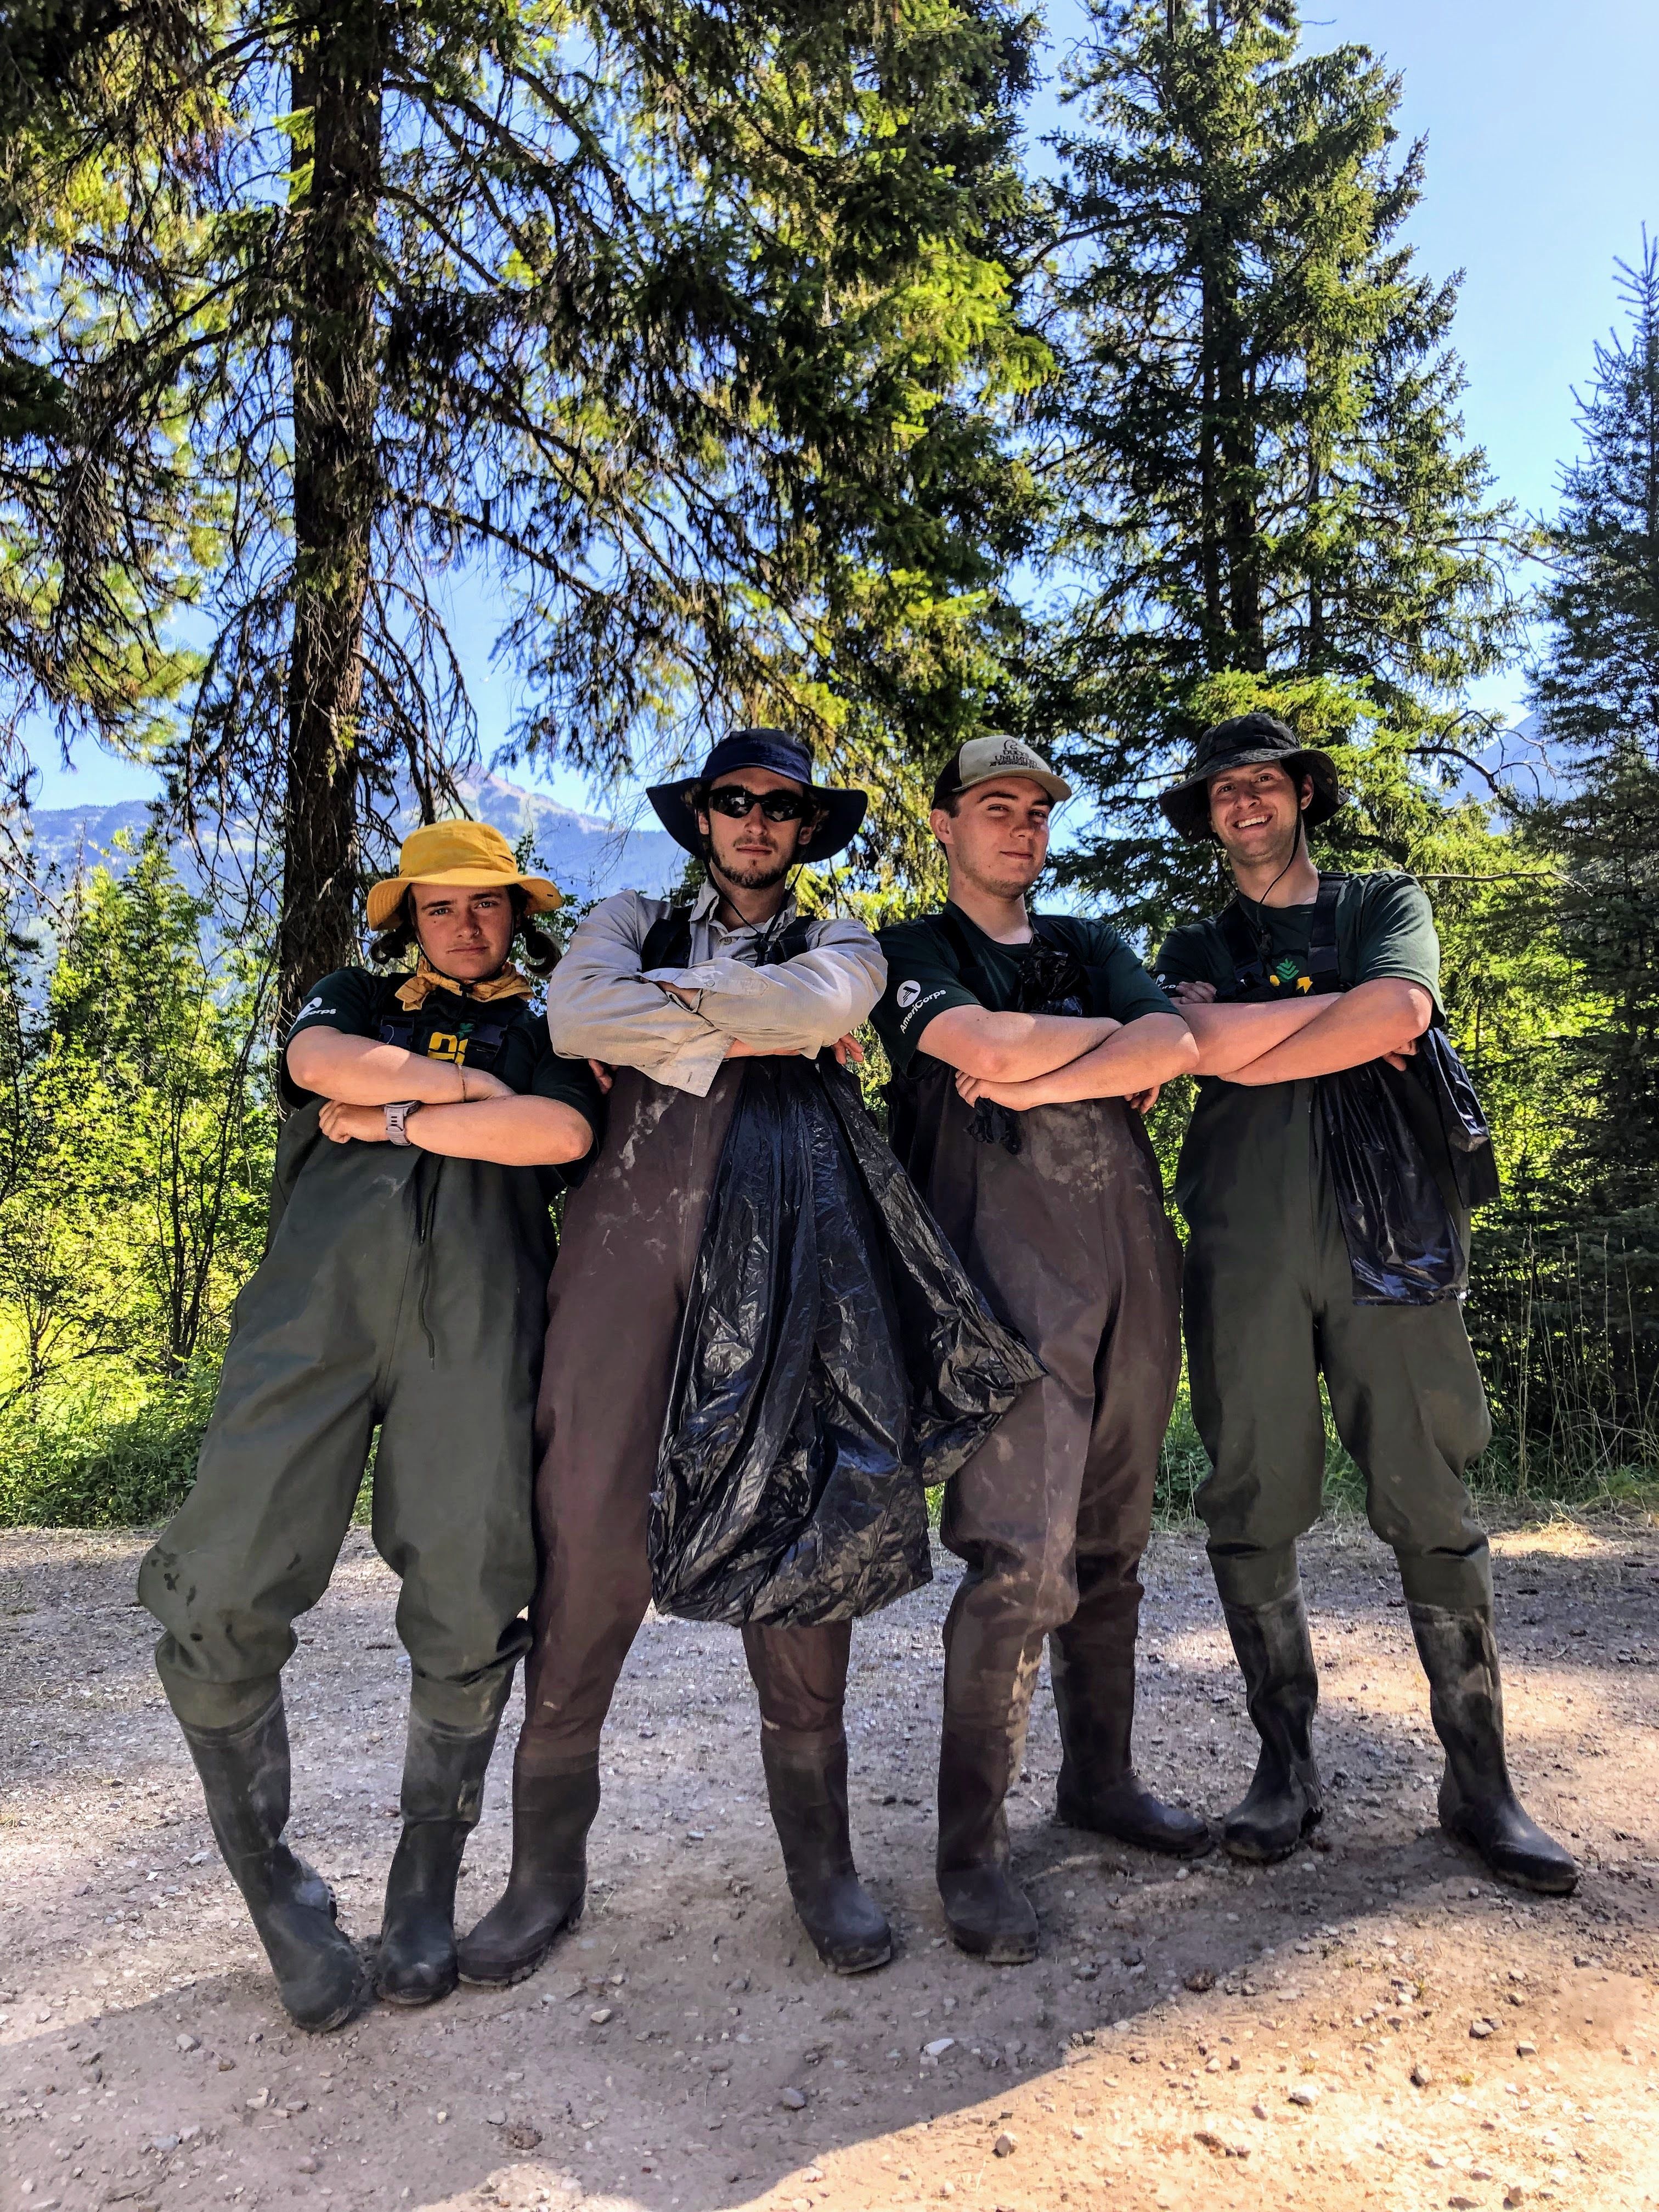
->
<box><xmin>546</xmin><ymin>891</ymin><xmax>732</xmax><ymax>1097</ymax></box>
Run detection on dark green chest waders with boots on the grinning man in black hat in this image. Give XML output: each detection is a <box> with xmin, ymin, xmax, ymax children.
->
<box><xmin>1175</xmin><ymin>876</ymin><xmax>1577</xmax><ymax>1891</ymax></box>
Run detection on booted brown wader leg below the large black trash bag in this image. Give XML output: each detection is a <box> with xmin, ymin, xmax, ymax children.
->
<box><xmin>743</xmin><ymin>1621</ymin><xmax>894</xmax><ymax>1973</ymax></box>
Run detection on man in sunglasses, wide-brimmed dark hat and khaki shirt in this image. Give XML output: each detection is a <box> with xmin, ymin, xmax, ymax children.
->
<box><xmin>460</xmin><ymin>728</ymin><xmax>911</xmax><ymax>1987</ymax></box>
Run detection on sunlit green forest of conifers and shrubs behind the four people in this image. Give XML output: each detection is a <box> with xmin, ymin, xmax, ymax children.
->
<box><xmin>0</xmin><ymin>0</ymin><xmax>1659</xmax><ymax>1522</ymax></box>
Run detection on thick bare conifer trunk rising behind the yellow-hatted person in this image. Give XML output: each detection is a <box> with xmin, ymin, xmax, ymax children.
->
<box><xmin>276</xmin><ymin>0</ymin><xmax>385</xmax><ymax>1026</ymax></box>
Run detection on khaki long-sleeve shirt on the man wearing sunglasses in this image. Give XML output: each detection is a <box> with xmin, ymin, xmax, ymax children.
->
<box><xmin>546</xmin><ymin>885</ymin><xmax>887</xmax><ymax>1097</ymax></box>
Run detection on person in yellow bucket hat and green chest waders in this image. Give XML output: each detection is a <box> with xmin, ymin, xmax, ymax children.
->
<box><xmin>139</xmin><ymin>821</ymin><xmax>604</xmax><ymax>2030</ymax></box>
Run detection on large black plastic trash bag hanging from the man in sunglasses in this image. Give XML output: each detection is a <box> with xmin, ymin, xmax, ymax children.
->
<box><xmin>650</xmin><ymin>1055</ymin><xmax>1044</xmax><ymax>1626</ymax></box>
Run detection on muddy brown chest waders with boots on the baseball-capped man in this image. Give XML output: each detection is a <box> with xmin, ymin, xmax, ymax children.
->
<box><xmin>891</xmin><ymin>916</ymin><xmax>1210</xmax><ymax>1964</ymax></box>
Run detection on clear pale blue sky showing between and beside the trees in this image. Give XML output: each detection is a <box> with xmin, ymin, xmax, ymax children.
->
<box><xmin>40</xmin><ymin>0</ymin><xmax>1659</xmax><ymax>805</ymax></box>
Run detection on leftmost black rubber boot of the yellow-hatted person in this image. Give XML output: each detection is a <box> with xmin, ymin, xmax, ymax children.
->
<box><xmin>182</xmin><ymin>1692</ymin><xmax>369</xmax><ymax>2035</ymax></box>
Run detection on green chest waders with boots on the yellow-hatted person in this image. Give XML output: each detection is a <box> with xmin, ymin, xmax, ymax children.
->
<box><xmin>139</xmin><ymin>1004</ymin><xmax>553</xmax><ymax>2030</ymax></box>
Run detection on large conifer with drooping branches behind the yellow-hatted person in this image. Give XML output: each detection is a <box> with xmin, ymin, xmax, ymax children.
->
<box><xmin>29</xmin><ymin>0</ymin><xmax>1042</xmax><ymax>1007</ymax></box>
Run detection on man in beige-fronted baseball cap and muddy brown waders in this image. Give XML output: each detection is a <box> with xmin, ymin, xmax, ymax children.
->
<box><xmin>876</xmin><ymin>737</ymin><xmax>1210</xmax><ymax>1964</ymax></box>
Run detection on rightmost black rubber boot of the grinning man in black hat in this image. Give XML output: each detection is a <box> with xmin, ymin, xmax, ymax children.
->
<box><xmin>1407</xmin><ymin>1604</ymin><xmax>1579</xmax><ymax>1898</ymax></box>
